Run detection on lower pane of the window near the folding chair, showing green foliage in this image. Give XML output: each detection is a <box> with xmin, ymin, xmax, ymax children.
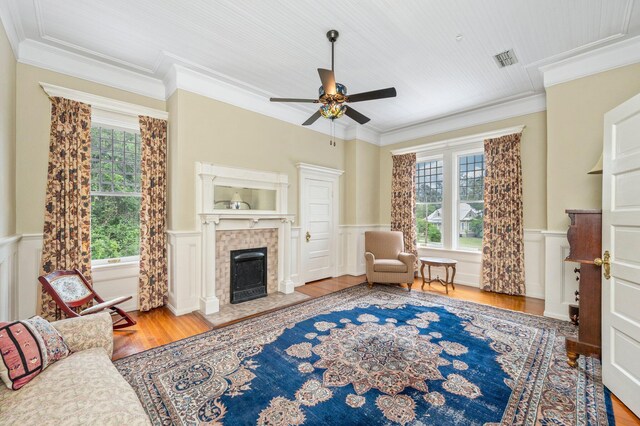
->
<box><xmin>91</xmin><ymin>195</ymin><xmax>140</xmax><ymax>260</ymax></box>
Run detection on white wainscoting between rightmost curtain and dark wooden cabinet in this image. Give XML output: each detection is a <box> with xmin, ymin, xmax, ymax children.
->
<box><xmin>543</xmin><ymin>231</ymin><xmax>580</xmax><ymax>320</ymax></box>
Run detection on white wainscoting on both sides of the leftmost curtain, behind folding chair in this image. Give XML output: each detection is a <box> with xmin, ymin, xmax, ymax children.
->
<box><xmin>17</xmin><ymin>234</ymin><xmax>140</xmax><ymax>318</ymax></box>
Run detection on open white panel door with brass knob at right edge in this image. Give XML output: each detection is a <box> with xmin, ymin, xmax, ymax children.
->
<box><xmin>602</xmin><ymin>90</ymin><xmax>640</xmax><ymax>416</ymax></box>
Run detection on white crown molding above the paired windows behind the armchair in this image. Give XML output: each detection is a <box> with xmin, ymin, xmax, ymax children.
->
<box><xmin>380</xmin><ymin>93</ymin><xmax>547</xmax><ymax>146</ymax></box>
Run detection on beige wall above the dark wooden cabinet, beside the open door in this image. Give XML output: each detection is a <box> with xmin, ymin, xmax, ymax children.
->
<box><xmin>547</xmin><ymin>64</ymin><xmax>640</xmax><ymax>231</ymax></box>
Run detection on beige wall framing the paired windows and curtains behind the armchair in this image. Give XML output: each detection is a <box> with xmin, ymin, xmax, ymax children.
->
<box><xmin>380</xmin><ymin>112</ymin><xmax>547</xmax><ymax>229</ymax></box>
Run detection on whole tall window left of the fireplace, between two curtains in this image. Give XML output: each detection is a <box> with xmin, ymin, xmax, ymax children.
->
<box><xmin>91</xmin><ymin>125</ymin><xmax>141</xmax><ymax>263</ymax></box>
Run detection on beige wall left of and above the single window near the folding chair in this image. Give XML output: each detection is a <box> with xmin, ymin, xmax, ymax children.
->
<box><xmin>16</xmin><ymin>63</ymin><xmax>165</xmax><ymax>234</ymax></box>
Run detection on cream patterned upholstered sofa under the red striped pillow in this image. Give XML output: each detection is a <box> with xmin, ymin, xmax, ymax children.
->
<box><xmin>0</xmin><ymin>312</ymin><xmax>150</xmax><ymax>426</ymax></box>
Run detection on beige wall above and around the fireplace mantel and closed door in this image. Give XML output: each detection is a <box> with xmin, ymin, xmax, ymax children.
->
<box><xmin>167</xmin><ymin>90</ymin><xmax>346</xmax><ymax>230</ymax></box>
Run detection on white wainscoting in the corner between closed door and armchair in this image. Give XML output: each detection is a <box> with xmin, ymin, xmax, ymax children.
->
<box><xmin>337</xmin><ymin>225</ymin><xmax>389</xmax><ymax>276</ymax></box>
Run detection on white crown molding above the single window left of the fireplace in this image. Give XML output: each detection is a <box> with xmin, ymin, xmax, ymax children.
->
<box><xmin>18</xmin><ymin>39</ymin><xmax>165</xmax><ymax>101</ymax></box>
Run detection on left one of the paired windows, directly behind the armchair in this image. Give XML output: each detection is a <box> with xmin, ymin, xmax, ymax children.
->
<box><xmin>416</xmin><ymin>159</ymin><xmax>443</xmax><ymax>247</ymax></box>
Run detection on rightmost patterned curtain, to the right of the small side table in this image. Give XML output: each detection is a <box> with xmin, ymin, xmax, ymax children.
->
<box><xmin>482</xmin><ymin>133</ymin><xmax>525</xmax><ymax>295</ymax></box>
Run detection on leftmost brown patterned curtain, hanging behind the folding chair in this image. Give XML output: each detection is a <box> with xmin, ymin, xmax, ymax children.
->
<box><xmin>40</xmin><ymin>98</ymin><xmax>91</xmax><ymax>320</ymax></box>
